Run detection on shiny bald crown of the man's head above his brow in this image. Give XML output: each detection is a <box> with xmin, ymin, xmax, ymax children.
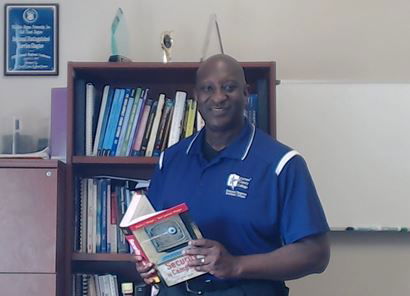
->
<box><xmin>196</xmin><ymin>54</ymin><xmax>246</xmax><ymax>86</ymax></box>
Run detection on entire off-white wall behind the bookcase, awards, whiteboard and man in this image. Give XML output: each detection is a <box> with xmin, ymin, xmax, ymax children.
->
<box><xmin>0</xmin><ymin>0</ymin><xmax>410</xmax><ymax>296</ymax></box>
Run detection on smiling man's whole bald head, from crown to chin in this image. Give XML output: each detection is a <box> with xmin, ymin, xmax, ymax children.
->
<box><xmin>195</xmin><ymin>55</ymin><xmax>248</xmax><ymax>133</ymax></box>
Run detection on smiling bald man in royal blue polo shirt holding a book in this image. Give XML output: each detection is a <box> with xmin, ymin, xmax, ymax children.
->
<box><xmin>136</xmin><ymin>55</ymin><xmax>330</xmax><ymax>296</ymax></box>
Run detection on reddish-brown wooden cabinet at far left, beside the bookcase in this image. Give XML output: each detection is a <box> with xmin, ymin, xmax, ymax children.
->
<box><xmin>0</xmin><ymin>160</ymin><xmax>65</xmax><ymax>295</ymax></box>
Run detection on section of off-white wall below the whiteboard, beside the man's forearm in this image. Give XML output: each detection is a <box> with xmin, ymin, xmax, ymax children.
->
<box><xmin>287</xmin><ymin>232</ymin><xmax>410</xmax><ymax>296</ymax></box>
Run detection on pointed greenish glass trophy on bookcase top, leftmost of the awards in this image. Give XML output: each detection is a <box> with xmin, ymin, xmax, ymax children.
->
<box><xmin>108</xmin><ymin>8</ymin><xmax>131</xmax><ymax>62</ymax></box>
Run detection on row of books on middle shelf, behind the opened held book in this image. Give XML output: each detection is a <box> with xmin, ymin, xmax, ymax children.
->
<box><xmin>74</xmin><ymin>176</ymin><xmax>148</xmax><ymax>253</ymax></box>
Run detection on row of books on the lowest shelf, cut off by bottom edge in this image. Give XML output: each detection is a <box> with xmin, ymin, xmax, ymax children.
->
<box><xmin>72</xmin><ymin>273</ymin><xmax>151</xmax><ymax>296</ymax></box>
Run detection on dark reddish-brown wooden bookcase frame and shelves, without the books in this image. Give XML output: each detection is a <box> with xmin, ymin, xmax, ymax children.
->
<box><xmin>65</xmin><ymin>62</ymin><xmax>276</xmax><ymax>295</ymax></box>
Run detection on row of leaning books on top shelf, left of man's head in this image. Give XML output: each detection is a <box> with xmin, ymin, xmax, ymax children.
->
<box><xmin>80</xmin><ymin>82</ymin><xmax>203</xmax><ymax>157</ymax></box>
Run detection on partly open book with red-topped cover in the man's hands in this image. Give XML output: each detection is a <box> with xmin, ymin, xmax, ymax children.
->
<box><xmin>120</xmin><ymin>191</ymin><xmax>204</xmax><ymax>286</ymax></box>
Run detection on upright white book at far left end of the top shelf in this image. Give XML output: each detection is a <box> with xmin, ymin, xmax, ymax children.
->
<box><xmin>85</xmin><ymin>82</ymin><xmax>96</xmax><ymax>155</ymax></box>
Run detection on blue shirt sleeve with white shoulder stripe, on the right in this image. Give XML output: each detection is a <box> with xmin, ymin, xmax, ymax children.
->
<box><xmin>278</xmin><ymin>155</ymin><xmax>329</xmax><ymax>244</ymax></box>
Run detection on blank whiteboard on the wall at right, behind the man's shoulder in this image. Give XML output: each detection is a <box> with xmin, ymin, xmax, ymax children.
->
<box><xmin>277</xmin><ymin>81</ymin><xmax>410</xmax><ymax>229</ymax></box>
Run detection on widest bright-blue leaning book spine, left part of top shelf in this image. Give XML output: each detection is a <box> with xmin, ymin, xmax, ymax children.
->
<box><xmin>103</xmin><ymin>88</ymin><xmax>125</xmax><ymax>155</ymax></box>
